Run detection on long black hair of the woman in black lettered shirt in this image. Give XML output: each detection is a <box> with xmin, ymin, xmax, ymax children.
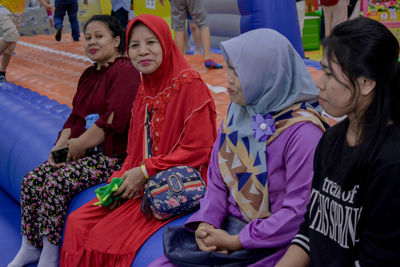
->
<box><xmin>322</xmin><ymin>18</ymin><xmax>400</xmax><ymax>188</ymax></box>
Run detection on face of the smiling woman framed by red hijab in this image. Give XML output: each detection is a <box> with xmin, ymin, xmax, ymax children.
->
<box><xmin>128</xmin><ymin>24</ymin><xmax>163</xmax><ymax>74</ymax></box>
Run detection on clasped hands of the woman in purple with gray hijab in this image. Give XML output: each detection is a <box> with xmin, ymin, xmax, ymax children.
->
<box><xmin>195</xmin><ymin>224</ymin><xmax>243</xmax><ymax>254</ymax></box>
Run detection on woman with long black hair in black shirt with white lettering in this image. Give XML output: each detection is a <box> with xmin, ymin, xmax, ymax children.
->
<box><xmin>277</xmin><ymin>18</ymin><xmax>400</xmax><ymax>267</ymax></box>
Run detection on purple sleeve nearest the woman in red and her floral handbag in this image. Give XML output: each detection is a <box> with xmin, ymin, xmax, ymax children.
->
<box><xmin>185</xmin><ymin>125</ymin><xmax>228</xmax><ymax>231</ymax></box>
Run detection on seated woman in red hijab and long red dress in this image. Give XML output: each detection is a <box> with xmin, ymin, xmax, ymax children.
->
<box><xmin>60</xmin><ymin>15</ymin><xmax>216</xmax><ymax>266</ymax></box>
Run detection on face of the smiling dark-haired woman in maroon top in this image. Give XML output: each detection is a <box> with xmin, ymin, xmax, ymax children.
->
<box><xmin>84</xmin><ymin>21</ymin><xmax>121</xmax><ymax>66</ymax></box>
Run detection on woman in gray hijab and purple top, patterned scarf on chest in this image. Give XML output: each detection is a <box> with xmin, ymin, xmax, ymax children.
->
<box><xmin>152</xmin><ymin>29</ymin><xmax>327</xmax><ymax>266</ymax></box>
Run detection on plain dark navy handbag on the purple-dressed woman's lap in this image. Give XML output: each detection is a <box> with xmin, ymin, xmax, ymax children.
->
<box><xmin>163</xmin><ymin>216</ymin><xmax>277</xmax><ymax>267</ymax></box>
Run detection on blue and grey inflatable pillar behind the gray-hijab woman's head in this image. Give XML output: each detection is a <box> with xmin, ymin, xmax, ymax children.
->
<box><xmin>204</xmin><ymin>0</ymin><xmax>304</xmax><ymax>58</ymax></box>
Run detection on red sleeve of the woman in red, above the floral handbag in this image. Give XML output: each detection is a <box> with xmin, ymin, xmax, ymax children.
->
<box><xmin>145</xmin><ymin>99</ymin><xmax>216</xmax><ymax>177</ymax></box>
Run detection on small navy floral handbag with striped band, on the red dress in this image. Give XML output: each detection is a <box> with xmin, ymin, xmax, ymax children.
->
<box><xmin>140</xmin><ymin>106</ymin><xmax>206</xmax><ymax>220</ymax></box>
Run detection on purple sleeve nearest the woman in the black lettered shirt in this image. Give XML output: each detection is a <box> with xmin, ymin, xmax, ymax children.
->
<box><xmin>239</xmin><ymin>123</ymin><xmax>322</xmax><ymax>249</ymax></box>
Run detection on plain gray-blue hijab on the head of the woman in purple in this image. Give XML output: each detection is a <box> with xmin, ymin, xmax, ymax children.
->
<box><xmin>221</xmin><ymin>28</ymin><xmax>318</xmax><ymax>114</ymax></box>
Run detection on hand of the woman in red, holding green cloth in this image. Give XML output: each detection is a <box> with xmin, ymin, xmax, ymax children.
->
<box><xmin>114</xmin><ymin>166</ymin><xmax>146</xmax><ymax>199</ymax></box>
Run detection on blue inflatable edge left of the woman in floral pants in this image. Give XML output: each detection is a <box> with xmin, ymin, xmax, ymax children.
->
<box><xmin>0</xmin><ymin>83</ymin><xmax>71</xmax><ymax>266</ymax></box>
